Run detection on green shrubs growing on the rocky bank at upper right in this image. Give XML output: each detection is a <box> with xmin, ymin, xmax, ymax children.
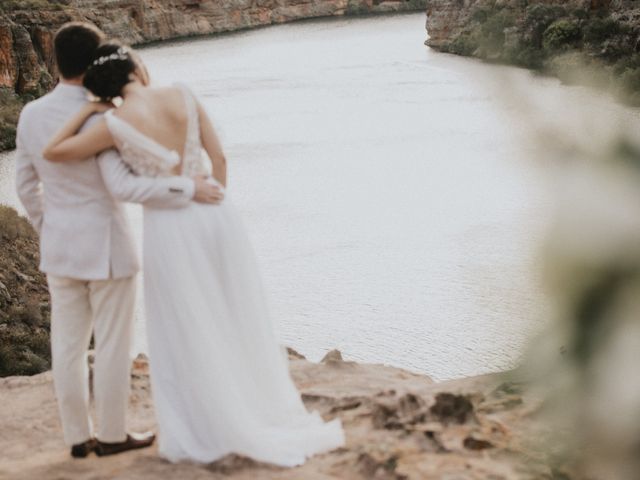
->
<box><xmin>443</xmin><ymin>3</ymin><xmax>640</xmax><ymax>105</ymax></box>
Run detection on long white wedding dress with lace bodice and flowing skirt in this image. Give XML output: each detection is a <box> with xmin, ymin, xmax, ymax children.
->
<box><xmin>106</xmin><ymin>86</ymin><xmax>344</xmax><ymax>466</ymax></box>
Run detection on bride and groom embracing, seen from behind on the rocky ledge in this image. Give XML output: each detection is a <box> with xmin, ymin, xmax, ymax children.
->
<box><xmin>16</xmin><ymin>23</ymin><xmax>344</xmax><ymax>466</ymax></box>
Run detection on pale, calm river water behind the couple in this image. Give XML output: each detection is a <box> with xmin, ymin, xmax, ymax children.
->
<box><xmin>5</xmin><ymin>14</ymin><xmax>637</xmax><ymax>379</ymax></box>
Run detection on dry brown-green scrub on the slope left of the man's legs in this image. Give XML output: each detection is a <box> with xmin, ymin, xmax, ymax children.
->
<box><xmin>0</xmin><ymin>205</ymin><xmax>51</xmax><ymax>377</ymax></box>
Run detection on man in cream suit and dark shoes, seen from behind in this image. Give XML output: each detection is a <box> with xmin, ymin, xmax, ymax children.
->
<box><xmin>16</xmin><ymin>23</ymin><xmax>222</xmax><ymax>457</ymax></box>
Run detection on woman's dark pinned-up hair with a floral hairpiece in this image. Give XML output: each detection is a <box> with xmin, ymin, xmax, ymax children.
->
<box><xmin>83</xmin><ymin>42</ymin><xmax>137</xmax><ymax>102</ymax></box>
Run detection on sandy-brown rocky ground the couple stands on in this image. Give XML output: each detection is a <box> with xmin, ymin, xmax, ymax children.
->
<box><xmin>0</xmin><ymin>351</ymin><xmax>568</xmax><ymax>480</ymax></box>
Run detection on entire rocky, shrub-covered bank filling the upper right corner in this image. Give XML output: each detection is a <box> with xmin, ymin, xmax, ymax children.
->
<box><xmin>427</xmin><ymin>0</ymin><xmax>640</xmax><ymax>106</ymax></box>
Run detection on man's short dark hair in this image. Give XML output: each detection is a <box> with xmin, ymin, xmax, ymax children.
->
<box><xmin>53</xmin><ymin>22</ymin><xmax>105</xmax><ymax>78</ymax></box>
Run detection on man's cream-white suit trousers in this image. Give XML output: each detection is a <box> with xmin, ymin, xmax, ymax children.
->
<box><xmin>47</xmin><ymin>275</ymin><xmax>136</xmax><ymax>445</ymax></box>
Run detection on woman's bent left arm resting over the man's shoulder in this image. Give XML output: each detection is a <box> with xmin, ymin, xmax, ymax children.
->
<box><xmin>42</xmin><ymin>102</ymin><xmax>114</xmax><ymax>162</ymax></box>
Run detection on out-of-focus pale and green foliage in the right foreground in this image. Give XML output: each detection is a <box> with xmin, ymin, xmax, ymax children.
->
<box><xmin>523</xmin><ymin>119</ymin><xmax>640</xmax><ymax>480</ymax></box>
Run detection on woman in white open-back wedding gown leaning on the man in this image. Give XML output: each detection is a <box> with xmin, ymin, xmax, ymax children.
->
<box><xmin>44</xmin><ymin>43</ymin><xmax>344</xmax><ymax>466</ymax></box>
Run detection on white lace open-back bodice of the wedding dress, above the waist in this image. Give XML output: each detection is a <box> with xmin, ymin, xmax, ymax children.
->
<box><xmin>105</xmin><ymin>84</ymin><xmax>210</xmax><ymax>177</ymax></box>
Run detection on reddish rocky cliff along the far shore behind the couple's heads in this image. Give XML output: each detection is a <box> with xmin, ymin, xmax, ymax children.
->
<box><xmin>0</xmin><ymin>0</ymin><xmax>426</xmax><ymax>150</ymax></box>
